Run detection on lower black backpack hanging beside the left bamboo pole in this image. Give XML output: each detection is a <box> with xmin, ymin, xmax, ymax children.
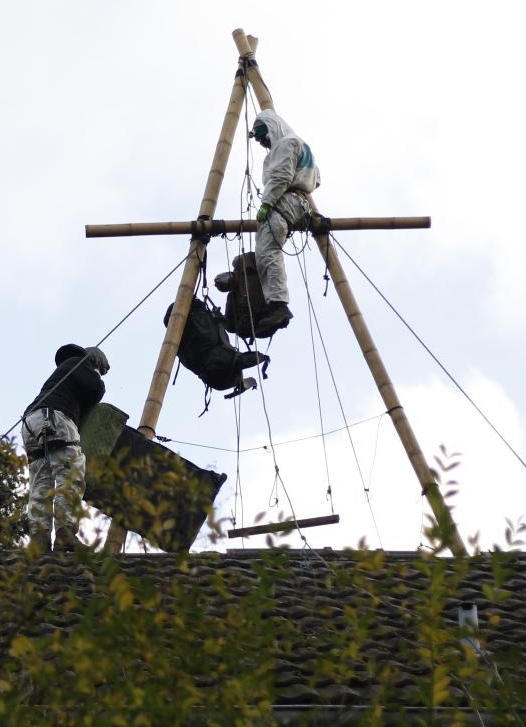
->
<box><xmin>164</xmin><ymin>298</ymin><xmax>270</xmax><ymax>410</ymax></box>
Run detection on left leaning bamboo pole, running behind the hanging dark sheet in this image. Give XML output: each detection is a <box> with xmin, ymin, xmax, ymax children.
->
<box><xmin>106</xmin><ymin>44</ymin><xmax>257</xmax><ymax>553</ymax></box>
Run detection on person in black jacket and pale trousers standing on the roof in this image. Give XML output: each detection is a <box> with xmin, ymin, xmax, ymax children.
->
<box><xmin>22</xmin><ymin>343</ymin><xmax>110</xmax><ymax>552</ymax></box>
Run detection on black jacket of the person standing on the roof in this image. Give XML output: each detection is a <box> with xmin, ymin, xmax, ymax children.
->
<box><xmin>24</xmin><ymin>357</ymin><xmax>106</xmax><ymax>427</ymax></box>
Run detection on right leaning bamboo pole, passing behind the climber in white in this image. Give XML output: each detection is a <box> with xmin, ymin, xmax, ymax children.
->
<box><xmin>232</xmin><ymin>29</ymin><xmax>467</xmax><ymax>555</ymax></box>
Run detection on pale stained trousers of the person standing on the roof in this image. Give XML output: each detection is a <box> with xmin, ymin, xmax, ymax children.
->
<box><xmin>22</xmin><ymin>408</ymin><xmax>86</xmax><ymax>535</ymax></box>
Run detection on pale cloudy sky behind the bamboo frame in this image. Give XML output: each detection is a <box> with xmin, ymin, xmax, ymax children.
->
<box><xmin>0</xmin><ymin>0</ymin><xmax>526</xmax><ymax>550</ymax></box>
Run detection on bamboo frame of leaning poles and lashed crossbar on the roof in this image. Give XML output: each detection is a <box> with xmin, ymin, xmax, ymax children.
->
<box><xmin>86</xmin><ymin>29</ymin><xmax>467</xmax><ymax>555</ymax></box>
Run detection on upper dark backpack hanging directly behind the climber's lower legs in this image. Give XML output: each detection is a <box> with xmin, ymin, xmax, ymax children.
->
<box><xmin>215</xmin><ymin>252</ymin><xmax>279</xmax><ymax>340</ymax></box>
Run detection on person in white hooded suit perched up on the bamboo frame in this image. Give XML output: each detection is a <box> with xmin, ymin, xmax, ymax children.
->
<box><xmin>250</xmin><ymin>109</ymin><xmax>320</xmax><ymax>335</ymax></box>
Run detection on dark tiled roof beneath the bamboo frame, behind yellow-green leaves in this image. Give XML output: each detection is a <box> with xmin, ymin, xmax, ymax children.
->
<box><xmin>0</xmin><ymin>549</ymin><xmax>526</xmax><ymax>724</ymax></box>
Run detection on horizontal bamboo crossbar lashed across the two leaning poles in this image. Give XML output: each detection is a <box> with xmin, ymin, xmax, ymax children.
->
<box><xmin>86</xmin><ymin>217</ymin><xmax>431</xmax><ymax>238</ymax></box>
